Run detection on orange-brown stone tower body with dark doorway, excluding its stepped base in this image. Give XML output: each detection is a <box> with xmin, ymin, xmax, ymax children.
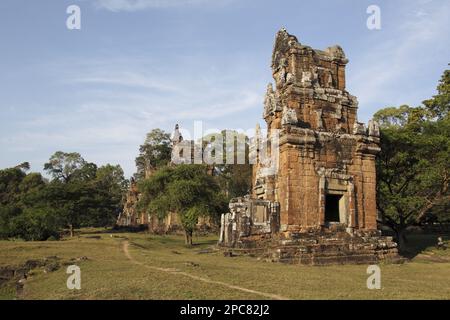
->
<box><xmin>255</xmin><ymin>29</ymin><xmax>380</xmax><ymax>231</ymax></box>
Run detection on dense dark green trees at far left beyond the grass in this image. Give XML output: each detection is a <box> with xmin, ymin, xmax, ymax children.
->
<box><xmin>0</xmin><ymin>152</ymin><xmax>128</xmax><ymax>240</ymax></box>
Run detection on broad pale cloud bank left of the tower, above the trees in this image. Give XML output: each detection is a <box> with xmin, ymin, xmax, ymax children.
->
<box><xmin>0</xmin><ymin>59</ymin><xmax>264</xmax><ymax>175</ymax></box>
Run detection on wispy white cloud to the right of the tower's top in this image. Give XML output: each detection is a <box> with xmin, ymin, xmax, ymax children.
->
<box><xmin>347</xmin><ymin>1</ymin><xmax>450</xmax><ymax>118</ymax></box>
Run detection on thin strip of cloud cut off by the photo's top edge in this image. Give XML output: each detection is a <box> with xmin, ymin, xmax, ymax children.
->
<box><xmin>95</xmin><ymin>0</ymin><xmax>232</xmax><ymax>12</ymax></box>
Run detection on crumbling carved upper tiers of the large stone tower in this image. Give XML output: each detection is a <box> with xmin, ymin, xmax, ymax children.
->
<box><xmin>264</xmin><ymin>29</ymin><xmax>358</xmax><ymax>133</ymax></box>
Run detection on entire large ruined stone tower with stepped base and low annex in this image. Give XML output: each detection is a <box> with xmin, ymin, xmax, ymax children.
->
<box><xmin>221</xmin><ymin>29</ymin><xmax>397</xmax><ymax>263</ymax></box>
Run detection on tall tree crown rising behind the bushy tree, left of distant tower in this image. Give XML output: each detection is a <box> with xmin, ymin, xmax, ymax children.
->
<box><xmin>136</xmin><ymin>129</ymin><xmax>172</xmax><ymax>180</ymax></box>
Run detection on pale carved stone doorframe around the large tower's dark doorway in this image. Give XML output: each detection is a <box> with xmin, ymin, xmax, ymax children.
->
<box><xmin>317</xmin><ymin>167</ymin><xmax>356</xmax><ymax>232</ymax></box>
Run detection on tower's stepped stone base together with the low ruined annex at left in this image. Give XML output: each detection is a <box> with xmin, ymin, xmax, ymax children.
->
<box><xmin>219</xmin><ymin>197</ymin><xmax>401</xmax><ymax>265</ymax></box>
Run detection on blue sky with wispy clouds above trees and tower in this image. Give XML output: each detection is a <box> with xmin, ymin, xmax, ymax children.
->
<box><xmin>0</xmin><ymin>0</ymin><xmax>450</xmax><ymax>176</ymax></box>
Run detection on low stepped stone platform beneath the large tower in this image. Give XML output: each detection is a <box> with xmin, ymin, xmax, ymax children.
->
<box><xmin>219</xmin><ymin>231</ymin><xmax>402</xmax><ymax>265</ymax></box>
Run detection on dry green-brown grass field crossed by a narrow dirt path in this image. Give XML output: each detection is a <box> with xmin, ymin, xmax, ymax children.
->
<box><xmin>0</xmin><ymin>230</ymin><xmax>450</xmax><ymax>300</ymax></box>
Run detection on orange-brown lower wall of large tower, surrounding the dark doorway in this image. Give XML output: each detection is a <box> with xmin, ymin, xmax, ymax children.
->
<box><xmin>276</xmin><ymin>128</ymin><xmax>379</xmax><ymax>229</ymax></box>
